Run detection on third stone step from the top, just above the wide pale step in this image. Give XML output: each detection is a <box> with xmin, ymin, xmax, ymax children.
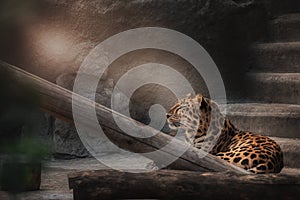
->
<box><xmin>247</xmin><ymin>73</ymin><xmax>300</xmax><ymax>104</ymax></box>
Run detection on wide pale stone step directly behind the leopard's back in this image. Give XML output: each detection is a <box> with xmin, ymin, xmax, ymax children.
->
<box><xmin>227</xmin><ymin>103</ymin><xmax>300</xmax><ymax>138</ymax></box>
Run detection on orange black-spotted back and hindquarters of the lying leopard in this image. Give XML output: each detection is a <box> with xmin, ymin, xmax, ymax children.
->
<box><xmin>216</xmin><ymin>132</ymin><xmax>283</xmax><ymax>174</ymax></box>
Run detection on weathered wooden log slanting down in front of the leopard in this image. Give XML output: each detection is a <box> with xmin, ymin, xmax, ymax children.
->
<box><xmin>0</xmin><ymin>61</ymin><xmax>248</xmax><ymax>174</ymax></box>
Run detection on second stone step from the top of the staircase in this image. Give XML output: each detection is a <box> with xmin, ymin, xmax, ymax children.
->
<box><xmin>249</xmin><ymin>42</ymin><xmax>300</xmax><ymax>73</ymax></box>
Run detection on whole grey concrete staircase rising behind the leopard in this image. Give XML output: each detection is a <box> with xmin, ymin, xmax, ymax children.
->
<box><xmin>227</xmin><ymin>13</ymin><xmax>300</xmax><ymax>172</ymax></box>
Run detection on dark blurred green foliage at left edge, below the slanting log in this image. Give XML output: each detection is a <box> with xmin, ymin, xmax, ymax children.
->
<box><xmin>0</xmin><ymin>66</ymin><xmax>50</xmax><ymax>192</ymax></box>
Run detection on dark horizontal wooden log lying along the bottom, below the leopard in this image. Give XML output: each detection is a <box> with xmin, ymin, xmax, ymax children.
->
<box><xmin>69</xmin><ymin>170</ymin><xmax>300</xmax><ymax>200</ymax></box>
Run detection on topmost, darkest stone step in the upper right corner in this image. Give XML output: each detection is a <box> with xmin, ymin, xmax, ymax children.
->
<box><xmin>269</xmin><ymin>13</ymin><xmax>300</xmax><ymax>42</ymax></box>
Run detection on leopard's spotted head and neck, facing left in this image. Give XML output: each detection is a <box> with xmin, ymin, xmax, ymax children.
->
<box><xmin>167</xmin><ymin>94</ymin><xmax>224</xmax><ymax>142</ymax></box>
